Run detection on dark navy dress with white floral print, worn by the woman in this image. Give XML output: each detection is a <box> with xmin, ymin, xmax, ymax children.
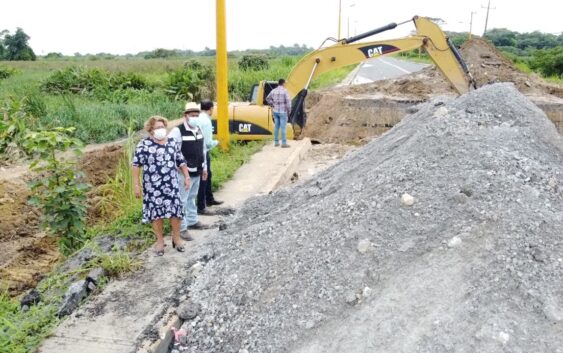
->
<box><xmin>132</xmin><ymin>137</ymin><xmax>186</xmax><ymax>223</ymax></box>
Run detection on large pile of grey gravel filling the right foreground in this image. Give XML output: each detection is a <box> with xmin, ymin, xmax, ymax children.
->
<box><xmin>181</xmin><ymin>84</ymin><xmax>563</xmax><ymax>353</ymax></box>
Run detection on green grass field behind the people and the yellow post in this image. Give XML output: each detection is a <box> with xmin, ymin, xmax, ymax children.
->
<box><xmin>0</xmin><ymin>57</ymin><xmax>352</xmax><ymax>143</ymax></box>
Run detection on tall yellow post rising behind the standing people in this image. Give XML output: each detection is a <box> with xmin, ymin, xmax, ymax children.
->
<box><xmin>216</xmin><ymin>0</ymin><xmax>229</xmax><ymax>151</ymax></box>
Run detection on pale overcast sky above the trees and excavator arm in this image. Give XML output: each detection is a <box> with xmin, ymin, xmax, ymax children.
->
<box><xmin>4</xmin><ymin>0</ymin><xmax>563</xmax><ymax>55</ymax></box>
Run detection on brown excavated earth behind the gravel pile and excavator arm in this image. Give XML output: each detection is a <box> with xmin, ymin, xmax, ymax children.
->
<box><xmin>303</xmin><ymin>38</ymin><xmax>563</xmax><ymax>144</ymax></box>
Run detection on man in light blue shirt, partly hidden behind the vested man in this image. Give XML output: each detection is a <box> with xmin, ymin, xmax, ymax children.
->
<box><xmin>194</xmin><ymin>99</ymin><xmax>223</xmax><ymax>215</ymax></box>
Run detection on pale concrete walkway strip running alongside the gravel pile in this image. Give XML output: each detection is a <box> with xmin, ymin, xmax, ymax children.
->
<box><xmin>39</xmin><ymin>139</ymin><xmax>311</xmax><ymax>353</ymax></box>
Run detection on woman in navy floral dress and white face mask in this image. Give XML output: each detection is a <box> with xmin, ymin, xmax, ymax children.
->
<box><xmin>132</xmin><ymin>116</ymin><xmax>190</xmax><ymax>256</ymax></box>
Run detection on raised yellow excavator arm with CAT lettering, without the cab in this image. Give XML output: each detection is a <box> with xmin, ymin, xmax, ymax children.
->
<box><xmin>286</xmin><ymin>16</ymin><xmax>475</xmax><ymax>132</ymax></box>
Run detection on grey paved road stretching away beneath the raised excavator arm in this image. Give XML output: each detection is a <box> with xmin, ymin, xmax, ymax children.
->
<box><xmin>345</xmin><ymin>57</ymin><xmax>429</xmax><ymax>85</ymax></box>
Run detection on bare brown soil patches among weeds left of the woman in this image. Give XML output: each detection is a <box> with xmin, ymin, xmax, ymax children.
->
<box><xmin>0</xmin><ymin>141</ymin><xmax>123</xmax><ymax>296</ymax></box>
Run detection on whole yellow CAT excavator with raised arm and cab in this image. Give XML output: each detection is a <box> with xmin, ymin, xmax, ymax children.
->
<box><xmin>203</xmin><ymin>16</ymin><xmax>475</xmax><ymax>140</ymax></box>
